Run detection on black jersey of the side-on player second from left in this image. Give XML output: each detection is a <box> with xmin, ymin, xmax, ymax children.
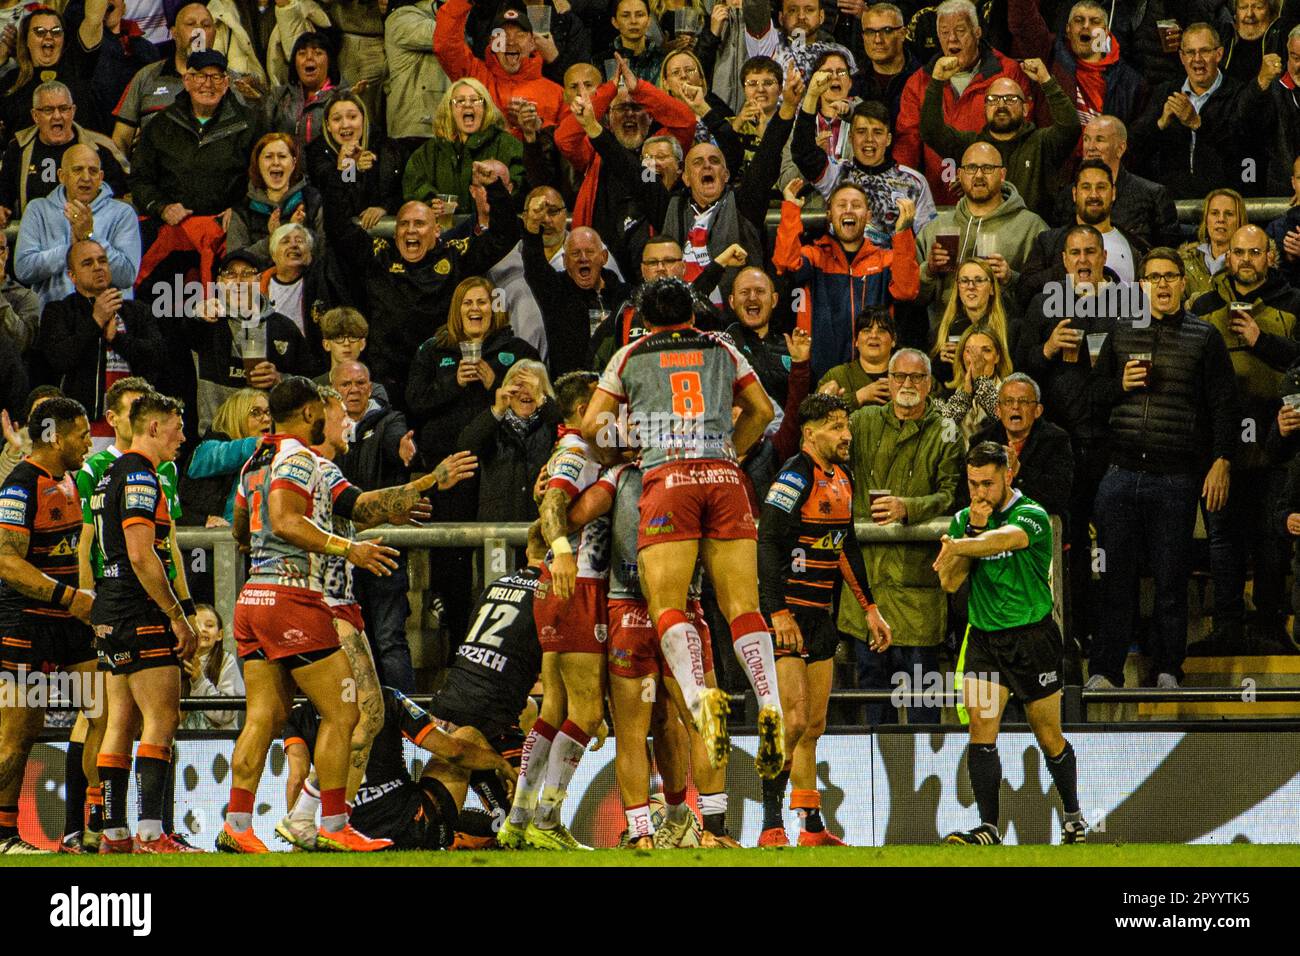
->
<box><xmin>90</xmin><ymin>451</ymin><xmax>172</xmax><ymax>624</ymax></box>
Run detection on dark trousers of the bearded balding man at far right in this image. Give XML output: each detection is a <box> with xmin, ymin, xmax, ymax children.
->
<box><xmin>1205</xmin><ymin>468</ymin><xmax>1290</xmax><ymax>627</ymax></box>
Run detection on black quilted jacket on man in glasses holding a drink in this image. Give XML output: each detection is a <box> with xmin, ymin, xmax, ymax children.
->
<box><xmin>1093</xmin><ymin>311</ymin><xmax>1242</xmax><ymax>475</ymax></box>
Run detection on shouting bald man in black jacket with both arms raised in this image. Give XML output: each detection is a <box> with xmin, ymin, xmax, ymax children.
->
<box><xmin>325</xmin><ymin>163</ymin><xmax>519</xmax><ymax>405</ymax></box>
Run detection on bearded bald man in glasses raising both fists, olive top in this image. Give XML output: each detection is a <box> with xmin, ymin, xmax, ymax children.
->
<box><xmin>920</xmin><ymin>56</ymin><xmax>1082</xmax><ymax>216</ymax></box>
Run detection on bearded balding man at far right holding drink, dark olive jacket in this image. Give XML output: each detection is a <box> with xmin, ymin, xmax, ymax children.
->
<box><xmin>1190</xmin><ymin>226</ymin><xmax>1300</xmax><ymax>653</ymax></box>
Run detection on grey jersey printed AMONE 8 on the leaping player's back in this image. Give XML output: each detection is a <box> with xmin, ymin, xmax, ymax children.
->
<box><xmin>597</xmin><ymin>328</ymin><xmax>757</xmax><ymax>471</ymax></box>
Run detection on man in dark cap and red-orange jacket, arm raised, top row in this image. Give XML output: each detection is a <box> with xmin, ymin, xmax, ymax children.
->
<box><xmin>433</xmin><ymin>0</ymin><xmax>564</xmax><ymax>137</ymax></box>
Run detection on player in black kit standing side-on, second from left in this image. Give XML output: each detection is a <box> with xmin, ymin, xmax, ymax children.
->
<box><xmin>91</xmin><ymin>392</ymin><xmax>196</xmax><ymax>853</ymax></box>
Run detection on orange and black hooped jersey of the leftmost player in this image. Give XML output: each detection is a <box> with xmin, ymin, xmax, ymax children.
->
<box><xmin>0</xmin><ymin>458</ymin><xmax>81</xmax><ymax>628</ymax></box>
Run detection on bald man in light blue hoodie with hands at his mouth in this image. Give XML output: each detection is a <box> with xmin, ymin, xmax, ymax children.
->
<box><xmin>13</xmin><ymin>143</ymin><xmax>140</xmax><ymax>308</ymax></box>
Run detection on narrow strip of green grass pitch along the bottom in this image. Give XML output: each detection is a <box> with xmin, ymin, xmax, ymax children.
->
<box><xmin>0</xmin><ymin>843</ymin><xmax>1300</xmax><ymax>869</ymax></box>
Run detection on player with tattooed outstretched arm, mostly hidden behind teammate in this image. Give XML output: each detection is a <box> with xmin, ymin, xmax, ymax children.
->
<box><xmin>276</xmin><ymin>388</ymin><xmax>477</xmax><ymax>849</ymax></box>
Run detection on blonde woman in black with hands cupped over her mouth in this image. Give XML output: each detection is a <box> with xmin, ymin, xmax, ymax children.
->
<box><xmin>456</xmin><ymin>359</ymin><xmax>563</xmax><ymax>522</ymax></box>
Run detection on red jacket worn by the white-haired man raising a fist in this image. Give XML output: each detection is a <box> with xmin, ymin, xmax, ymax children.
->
<box><xmin>893</xmin><ymin>44</ymin><xmax>1034</xmax><ymax>206</ymax></box>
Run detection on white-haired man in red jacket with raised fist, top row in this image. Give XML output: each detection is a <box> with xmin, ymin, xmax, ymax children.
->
<box><xmin>894</xmin><ymin>0</ymin><xmax>1034</xmax><ymax>206</ymax></box>
